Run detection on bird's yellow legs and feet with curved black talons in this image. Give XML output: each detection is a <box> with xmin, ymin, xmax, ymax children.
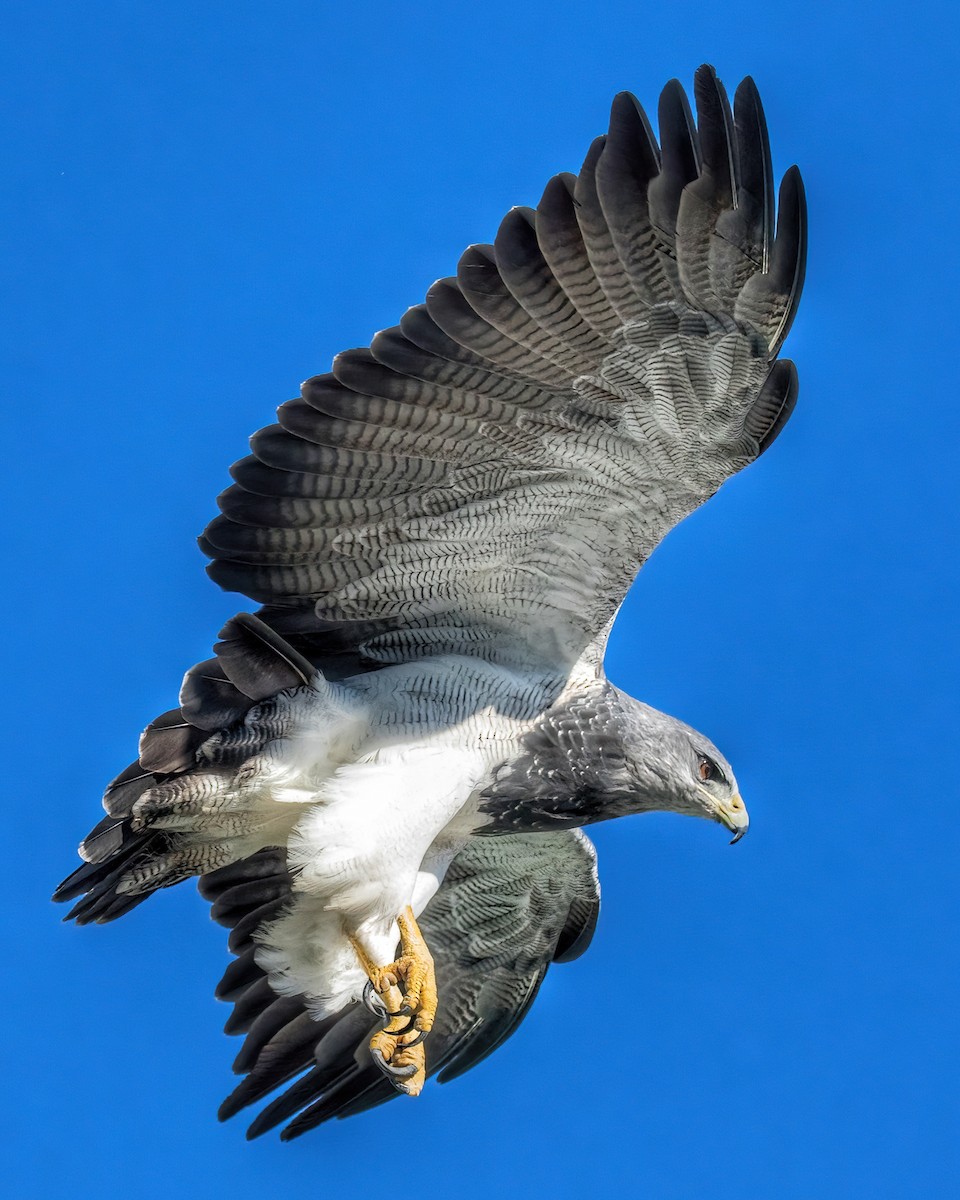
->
<box><xmin>350</xmin><ymin>906</ymin><xmax>438</xmax><ymax>1096</ymax></box>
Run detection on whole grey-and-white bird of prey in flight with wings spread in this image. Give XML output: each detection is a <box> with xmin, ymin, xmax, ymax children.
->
<box><xmin>55</xmin><ymin>66</ymin><xmax>805</xmax><ymax>1138</ymax></box>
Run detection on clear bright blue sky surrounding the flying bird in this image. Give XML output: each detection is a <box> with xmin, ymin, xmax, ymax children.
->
<box><xmin>0</xmin><ymin>0</ymin><xmax>960</xmax><ymax>1200</ymax></box>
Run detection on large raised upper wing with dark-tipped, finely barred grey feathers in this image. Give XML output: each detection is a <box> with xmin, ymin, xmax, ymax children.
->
<box><xmin>202</xmin><ymin>66</ymin><xmax>805</xmax><ymax>674</ymax></box>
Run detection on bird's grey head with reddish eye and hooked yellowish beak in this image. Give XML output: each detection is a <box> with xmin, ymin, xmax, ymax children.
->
<box><xmin>619</xmin><ymin>692</ymin><xmax>750</xmax><ymax>841</ymax></box>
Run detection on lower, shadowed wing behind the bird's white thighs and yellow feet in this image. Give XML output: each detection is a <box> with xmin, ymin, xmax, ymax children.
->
<box><xmin>199</xmin><ymin>832</ymin><xmax>600</xmax><ymax>1138</ymax></box>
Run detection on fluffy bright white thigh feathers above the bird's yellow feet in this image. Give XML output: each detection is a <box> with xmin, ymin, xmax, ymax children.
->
<box><xmin>249</xmin><ymin>746</ymin><xmax>486</xmax><ymax>1016</ymax></box>
